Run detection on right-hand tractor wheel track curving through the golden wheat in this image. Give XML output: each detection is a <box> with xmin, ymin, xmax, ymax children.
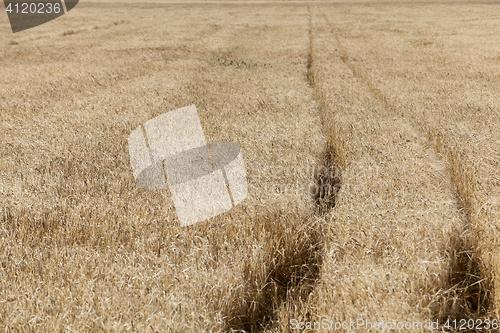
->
<box><xmin>316</xmin><ymin>7</ymin><xmax>492</xmax><ymax>321</ymax></box>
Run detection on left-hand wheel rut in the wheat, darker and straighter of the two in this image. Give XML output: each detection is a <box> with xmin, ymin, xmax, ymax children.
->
<box><xmin>226</xmin><ymin>6</ymin><xmax>341</xmax><ymax>332</ymax></box>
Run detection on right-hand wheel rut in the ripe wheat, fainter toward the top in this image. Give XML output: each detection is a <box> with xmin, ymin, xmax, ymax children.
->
<box><xmin>312</xmin><ymin>8</ymin><xmax>493</xmax><ymax>322</ymax></box>
